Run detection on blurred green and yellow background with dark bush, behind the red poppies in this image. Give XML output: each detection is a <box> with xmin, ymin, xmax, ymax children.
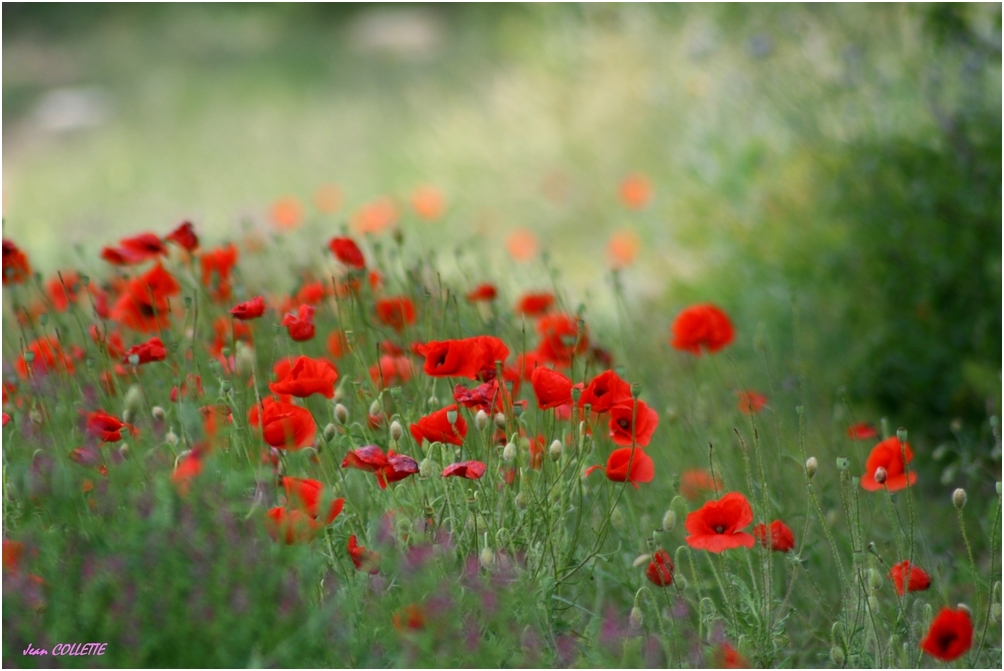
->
<box><xmin>3</xmin><ymin>3</ymin><xmax>1001</xmax><ymax>439</ymax></box>
